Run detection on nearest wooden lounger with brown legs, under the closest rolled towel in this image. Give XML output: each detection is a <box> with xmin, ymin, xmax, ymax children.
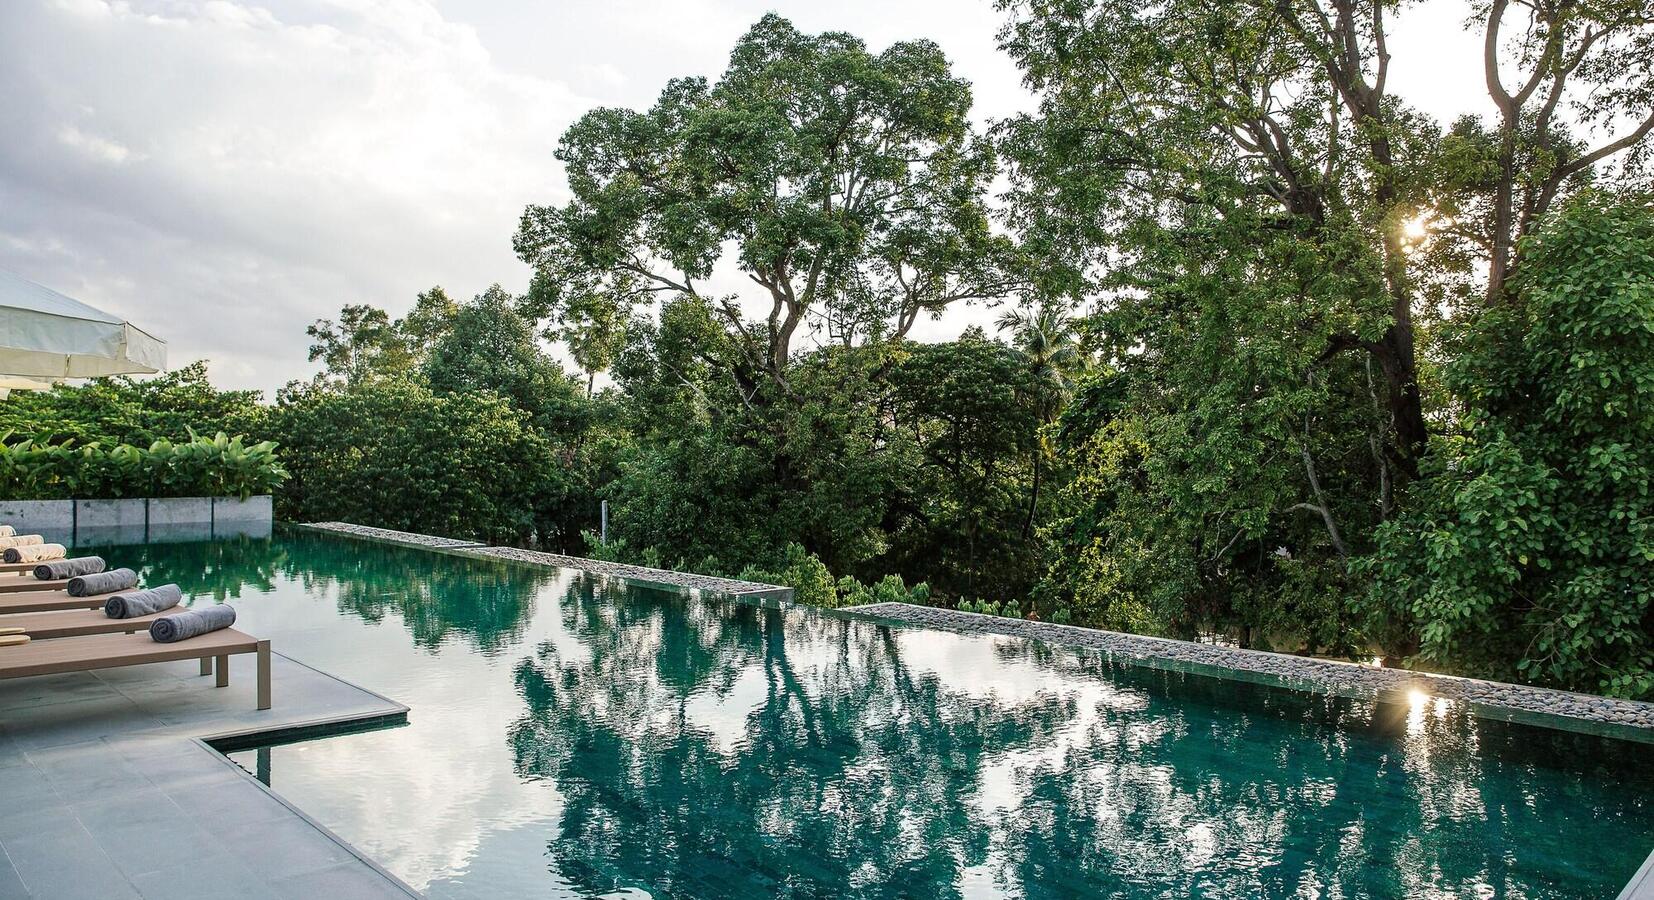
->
<box><xmin>0</xmin><ymin>629</ymin><xmax>270</xmax><ymax>710</ymax></box>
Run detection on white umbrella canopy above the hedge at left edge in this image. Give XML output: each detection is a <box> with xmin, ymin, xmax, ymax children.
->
<box><xmin>0</xmin><ymin>270</ymin><xmax>167</xmax><ymax>380</ymax></box>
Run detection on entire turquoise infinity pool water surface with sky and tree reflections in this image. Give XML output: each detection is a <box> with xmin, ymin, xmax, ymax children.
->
<box><xmin>71</xmin><ymin>531</ymin><xmax>1654</xmax><ymax>898</ymax></box>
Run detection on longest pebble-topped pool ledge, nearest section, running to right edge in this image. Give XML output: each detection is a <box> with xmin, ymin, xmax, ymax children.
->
<box><xmin>845</xmin><ymin>604</ymin><xmax>1654</xmax><ymax>743</ymax></box>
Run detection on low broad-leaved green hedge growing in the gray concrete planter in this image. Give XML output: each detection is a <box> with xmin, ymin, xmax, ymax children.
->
<box><xmin>0</xmin><ymin>432</ymin><xmax>288</xmax><ymax>500</ymax></box>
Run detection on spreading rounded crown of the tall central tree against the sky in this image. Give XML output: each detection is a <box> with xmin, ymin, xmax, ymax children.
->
<box><xmin>516</xmin><ymin>15</ymin><xmax>1011</xmax><ymax>397</ymax></box>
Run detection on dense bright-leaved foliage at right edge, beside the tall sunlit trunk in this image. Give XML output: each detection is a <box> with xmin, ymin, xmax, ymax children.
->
<box><xmin>1373</xmin><ymin>195</ymin><xmax>1654</xmax><ymax>697</ymax></box>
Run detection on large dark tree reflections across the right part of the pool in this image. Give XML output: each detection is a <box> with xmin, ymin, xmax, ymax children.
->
<box><xmin>509</xmin><ymin>582</ymin><xmax>1654</xmax><ymax>897</ymax></box>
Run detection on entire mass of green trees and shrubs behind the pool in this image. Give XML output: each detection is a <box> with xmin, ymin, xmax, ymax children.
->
<box><xmin>0</xmin><ymin>0</ymin><xmax>1654</xmax><ymax>698</ymax></box>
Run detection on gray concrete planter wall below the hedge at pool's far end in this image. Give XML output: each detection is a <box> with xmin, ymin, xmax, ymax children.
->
<box><xmin>0</xmin><ymin>495</ymin><xmax>275</xmax><ymax>544</ymax></box>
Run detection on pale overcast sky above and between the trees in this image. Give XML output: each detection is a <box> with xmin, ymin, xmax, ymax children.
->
<box><xmin>0</xmin><ymin>0</ymin><xmax>1489</xmax><ymax>390</ymax></box>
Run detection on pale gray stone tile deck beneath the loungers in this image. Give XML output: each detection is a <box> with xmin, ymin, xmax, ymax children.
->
<box><xmin>0</xmin><ymin>653</ymin><xmax>417</xmax><ymax>900</ymax></box>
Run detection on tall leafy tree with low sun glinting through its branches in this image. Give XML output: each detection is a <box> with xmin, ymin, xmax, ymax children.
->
<box><xmin>1002</xmin><ymin>0</ymin><xmax>1654</xmax><ymax>653</ymax></box>
